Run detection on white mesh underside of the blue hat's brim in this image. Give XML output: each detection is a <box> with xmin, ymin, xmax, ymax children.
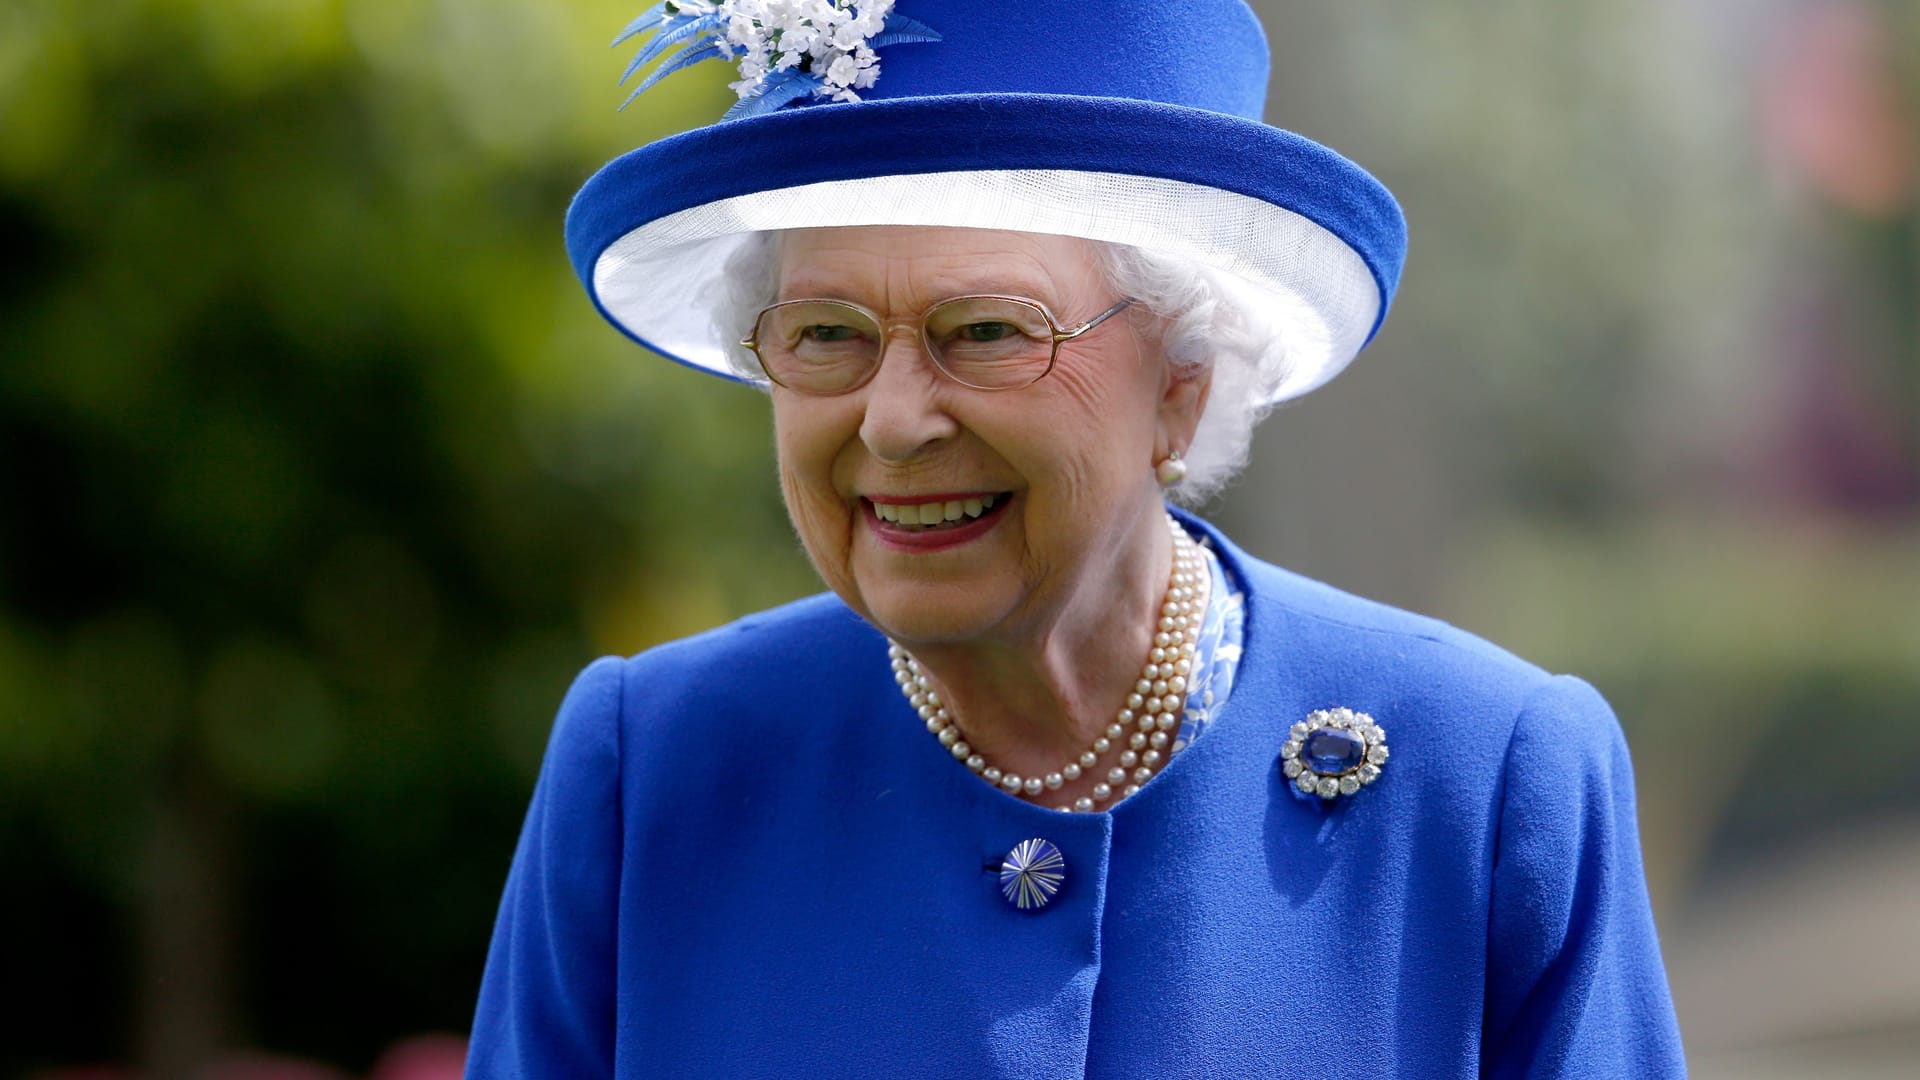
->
<box><xmin>593</xmin><ymin>169</ymin><xmax>1380</xmax><ymax>402</ymax></box>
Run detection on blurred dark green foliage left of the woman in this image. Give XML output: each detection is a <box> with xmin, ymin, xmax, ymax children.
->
<box><xmin>0</xmin><ymin>0</ymin><xmax>814</xmax><ymax>1074</ymax></box>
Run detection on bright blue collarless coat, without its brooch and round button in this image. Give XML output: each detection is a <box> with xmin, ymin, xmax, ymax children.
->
<box><xmin>468</xmin><ymin>527</ymin><xmax>1684</xmax><ymax>1080</ymax></box>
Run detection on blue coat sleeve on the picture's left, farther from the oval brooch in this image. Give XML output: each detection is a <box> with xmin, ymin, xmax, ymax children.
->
<box><xmin>467</xmin><ymin>659</ymin><xmax>624</xmax><ymax>1080</ymax></box>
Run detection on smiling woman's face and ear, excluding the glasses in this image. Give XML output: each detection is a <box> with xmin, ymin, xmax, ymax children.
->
<box><xmin>772</xmin><ymin>227</ymin><xmax>1204</xmax><ymax>644</ymax></box>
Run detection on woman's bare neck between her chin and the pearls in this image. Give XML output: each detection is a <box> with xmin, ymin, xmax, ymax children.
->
<box><xmin>912</xmin><ymin>505</ymin><xmax>1173</xmax><ymax>782</ymax></box>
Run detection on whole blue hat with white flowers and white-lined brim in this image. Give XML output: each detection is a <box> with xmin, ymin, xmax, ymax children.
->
<box><xmin>566</xmin><ymin>0</ymin><xmax>1405</xmax><ymax>402</ymax></box>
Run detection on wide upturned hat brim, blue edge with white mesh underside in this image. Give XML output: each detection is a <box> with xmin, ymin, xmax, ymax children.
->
<box><xmin>566</xmin><ymin>94</ymin><xmax>1405</xmax><ymax>402</ymax></box>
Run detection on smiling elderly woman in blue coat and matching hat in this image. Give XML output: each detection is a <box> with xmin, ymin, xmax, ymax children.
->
<box><xmin>470</xmin><ymin>0</ymin><xmax>1682</xmax><ymax>1078</ymax></box>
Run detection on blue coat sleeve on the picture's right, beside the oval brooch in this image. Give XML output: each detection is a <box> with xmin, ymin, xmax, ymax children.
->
<box><xmin>1482</xmin><ymin>676</ymin><xmax>1686</xmax><ymax>1080</ymax></box>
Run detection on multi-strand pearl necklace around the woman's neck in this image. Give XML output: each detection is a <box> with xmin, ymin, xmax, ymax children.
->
<box><xmin>887</xmin><ymin>515</ymin><xmax>1212</xmax><ymax>813</ymax></box>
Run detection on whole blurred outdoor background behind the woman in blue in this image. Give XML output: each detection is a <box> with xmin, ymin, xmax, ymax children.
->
<box><xmin>0</xmin><ymin>0</ymin><xmax>1920</xmax><ymax>1080</ymax></box>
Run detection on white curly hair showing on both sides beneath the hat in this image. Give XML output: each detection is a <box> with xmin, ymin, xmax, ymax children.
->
<box><xmin>714</xmin><ymin>233</ymin><xmax>1288</xmax><ymax>505</ymax></box>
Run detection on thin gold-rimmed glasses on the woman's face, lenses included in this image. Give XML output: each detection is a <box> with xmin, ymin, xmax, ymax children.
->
<box><xmin>739</xmin><ymin>294</ymin><xmax>1133</xmax><ymax>396</ymax></box>
